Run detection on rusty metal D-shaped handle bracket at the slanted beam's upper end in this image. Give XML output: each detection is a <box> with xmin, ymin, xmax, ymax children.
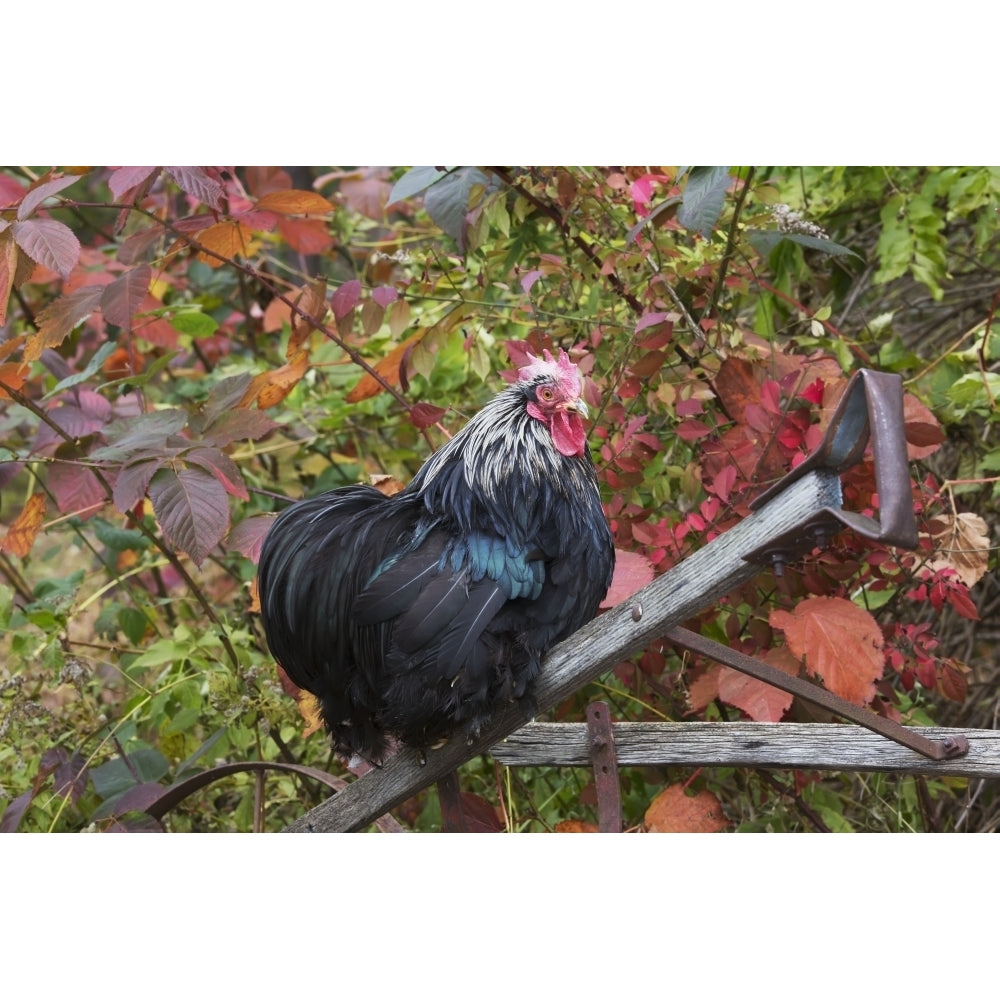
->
<box><xmin>743</xmin><ymin>368</ymin><xmax>917</xmax><ymax>574</ymax></box>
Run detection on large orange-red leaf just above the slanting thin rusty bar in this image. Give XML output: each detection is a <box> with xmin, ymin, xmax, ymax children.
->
<box><xmin>770</xmin><ymin>597</ymin><xmax>885</xmax><ymax>705</ymax></box>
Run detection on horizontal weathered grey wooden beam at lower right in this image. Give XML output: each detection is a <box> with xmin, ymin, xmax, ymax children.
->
<box><xmin>490</xmin><ymin>722</ymin><xmax>1000</xmax><ymax>778</ymax></box>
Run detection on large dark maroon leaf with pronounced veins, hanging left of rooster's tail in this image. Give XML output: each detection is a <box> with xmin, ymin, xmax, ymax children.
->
<box><xmin>149</xmin><ymin>469</ymin><xmax>229</xmax><ymax>566</ymax></box>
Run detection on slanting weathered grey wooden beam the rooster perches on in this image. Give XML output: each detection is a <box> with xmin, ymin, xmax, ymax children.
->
<box><xmin>287</xmin><ymin>469</ymin><xmax>842</xmax><ymax>833</ymax></box>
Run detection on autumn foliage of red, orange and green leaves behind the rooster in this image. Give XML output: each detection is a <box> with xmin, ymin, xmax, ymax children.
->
<box><xmin>0</xmin><ymin>167</ymin><xmax>1000</xmax><ymax>830</ymax></box>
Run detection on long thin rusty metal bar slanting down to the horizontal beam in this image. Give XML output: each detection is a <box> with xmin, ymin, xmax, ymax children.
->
<box><xmin>666</xmin><ymin>628</ymin><xmax>969</xmax><ymax>760</ymax></box>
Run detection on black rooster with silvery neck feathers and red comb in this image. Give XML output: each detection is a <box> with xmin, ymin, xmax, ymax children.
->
<box><xmin>259</xmin><ymin>351</ymin><xmax>614</xmax><ymax>762</ymax></box>
